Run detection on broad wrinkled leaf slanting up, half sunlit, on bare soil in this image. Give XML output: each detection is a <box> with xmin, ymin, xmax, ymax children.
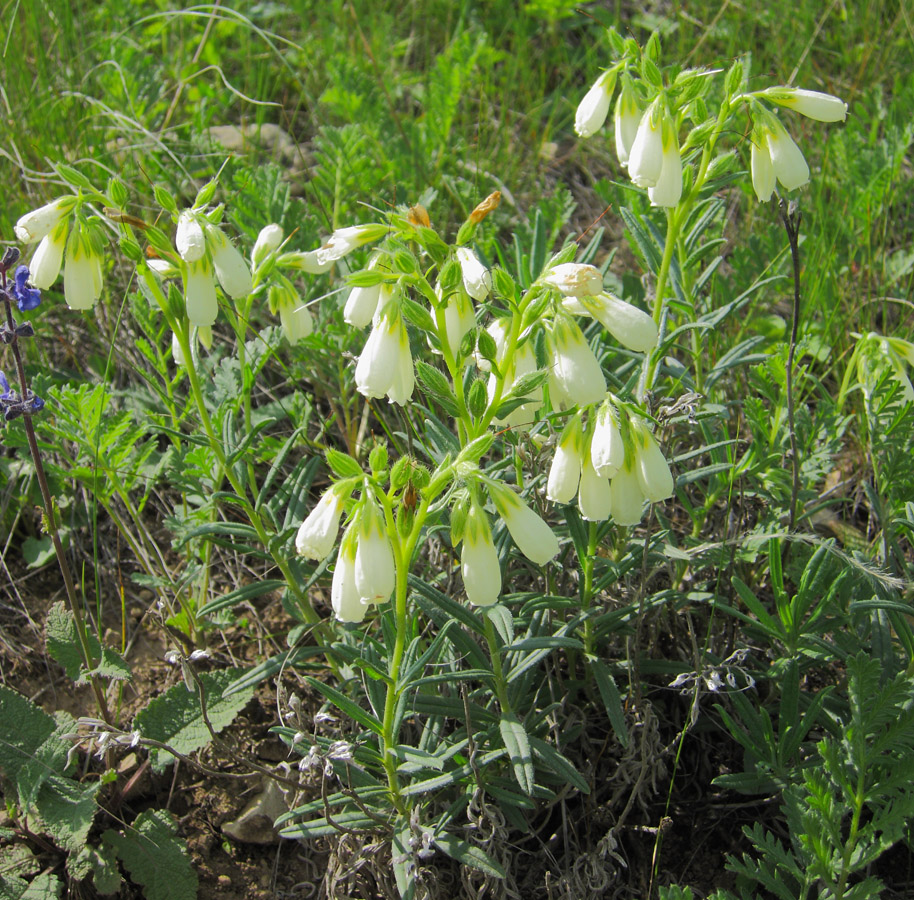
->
<box><xmin>133</xmin><ymin>669</ymin><xmax>254</xmax><ymax>770</ymax></box>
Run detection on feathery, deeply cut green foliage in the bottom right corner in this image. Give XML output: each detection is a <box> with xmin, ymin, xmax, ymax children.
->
<box><xmin>728</xmin><ymin>653</ymin><xmax>914</xmax><ymax>900</ymax></box>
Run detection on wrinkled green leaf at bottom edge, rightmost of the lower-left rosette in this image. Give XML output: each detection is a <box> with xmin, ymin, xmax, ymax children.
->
<box><xmin>102</xmin><ymin>809</ymin><xmax>197</xmax><ymax>900</ymax></box>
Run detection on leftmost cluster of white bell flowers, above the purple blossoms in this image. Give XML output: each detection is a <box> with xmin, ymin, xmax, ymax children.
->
<box><xmin>15</xmin><ymin>194</ymin><xmax>103</xmax><ymax>309</ymax></box>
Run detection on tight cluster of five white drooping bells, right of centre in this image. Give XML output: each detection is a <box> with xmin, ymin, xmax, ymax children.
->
<box><xmin>546</xmin><ymin>399</ymin><xmax>673</xmax><ymax>525</ymax></box>
